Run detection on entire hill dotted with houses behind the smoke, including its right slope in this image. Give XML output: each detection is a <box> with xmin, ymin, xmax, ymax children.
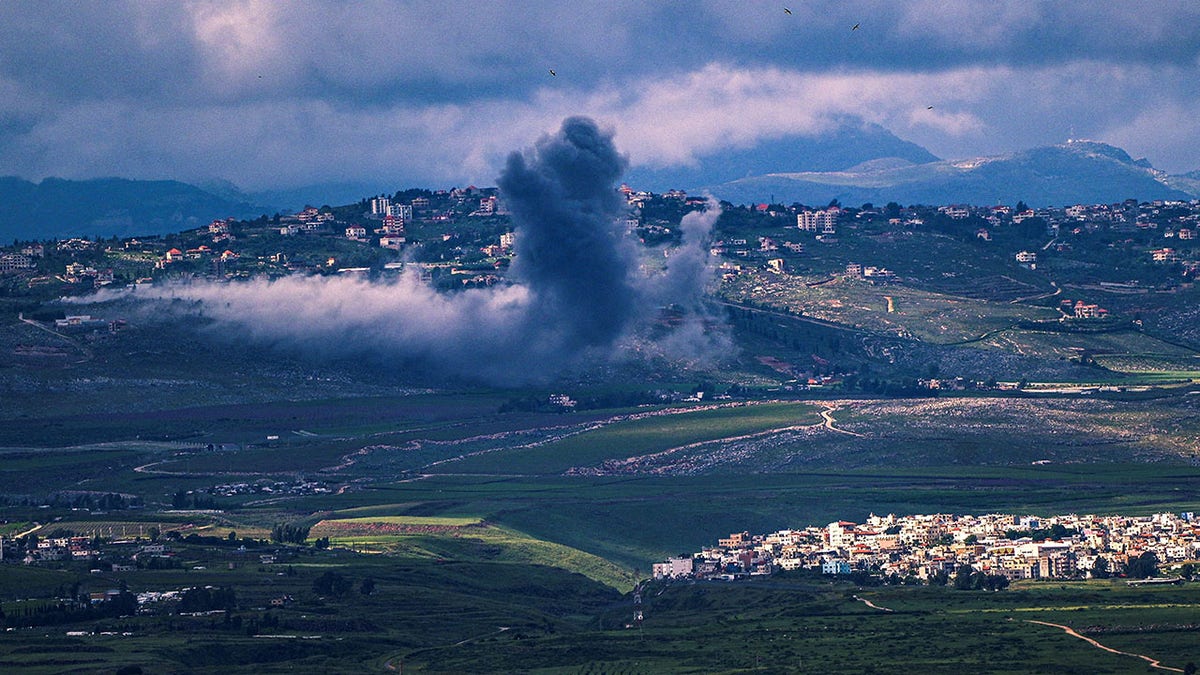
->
<box><xmin>0</xmin><ymin>185</ymin><xmax>1200</xmax><ymax>395</ymax></box>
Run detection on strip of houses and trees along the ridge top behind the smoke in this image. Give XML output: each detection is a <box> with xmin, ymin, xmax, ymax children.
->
<box><xmin>0</xmin><ymin>185</ymin><xmax>1200</xmax><ymax>294</ymax></box>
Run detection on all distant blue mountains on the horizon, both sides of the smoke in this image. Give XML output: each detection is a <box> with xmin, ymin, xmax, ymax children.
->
<box><xmin>0</xmin><ymin>132</ymin><xmax>1200</xmax><ymax>243</ymax></box>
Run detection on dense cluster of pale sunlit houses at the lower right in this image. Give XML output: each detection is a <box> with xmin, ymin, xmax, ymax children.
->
<box><xmin>653</xmin><ymin>513</ymin><xmax>1200</xmax><ymax>581</ymax></box>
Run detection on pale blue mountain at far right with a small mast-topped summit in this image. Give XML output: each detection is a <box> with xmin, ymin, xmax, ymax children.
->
<box><xmin>706</xmin><ymin>141</ymin><xmax>1200</xmax><ymax>207</ymax></box>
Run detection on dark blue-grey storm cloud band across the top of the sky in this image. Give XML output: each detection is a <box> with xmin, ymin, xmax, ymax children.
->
<box><xmin>0</xmin><ymin>0</ymin><xmax>1200</xmax><ymax>106</ymax></box>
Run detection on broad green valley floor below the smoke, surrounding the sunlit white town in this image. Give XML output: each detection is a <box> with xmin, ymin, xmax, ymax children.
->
<box><xmin>7</xmin><ymin>357</ymin><xmax>1200</xmax><ymax>673</ymax></box>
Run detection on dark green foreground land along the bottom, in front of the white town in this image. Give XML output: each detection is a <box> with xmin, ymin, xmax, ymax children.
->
<box><xmin>0</xmin><ymin>564</ymin><xmax>1200</xmax><ymax>674</ymax></box>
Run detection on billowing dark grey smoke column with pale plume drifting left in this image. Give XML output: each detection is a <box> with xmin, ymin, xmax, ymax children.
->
<box><xmin>88</xmin><ymin>118</ymin><xmax>726</xmax><ymax>383</ymax></box>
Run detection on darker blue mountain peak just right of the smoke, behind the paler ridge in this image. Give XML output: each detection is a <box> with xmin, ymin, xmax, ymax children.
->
<box><xmin>623</xmin><ymin>119</ymin><xmax>938</xmax><ymax>192</ymax></box>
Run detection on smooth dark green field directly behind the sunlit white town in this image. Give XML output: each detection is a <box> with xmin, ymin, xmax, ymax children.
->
<box><xmin>355</xmin><ymin>464</ymin><xmax>1200</xmax><ymax>574</ymax></box>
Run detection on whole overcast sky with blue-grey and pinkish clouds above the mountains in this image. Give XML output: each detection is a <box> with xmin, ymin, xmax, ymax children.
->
<box><xmin>0</xmin><ymin>0</ymin><xmax>1200</xmax><ymax>190</ymax></box>
